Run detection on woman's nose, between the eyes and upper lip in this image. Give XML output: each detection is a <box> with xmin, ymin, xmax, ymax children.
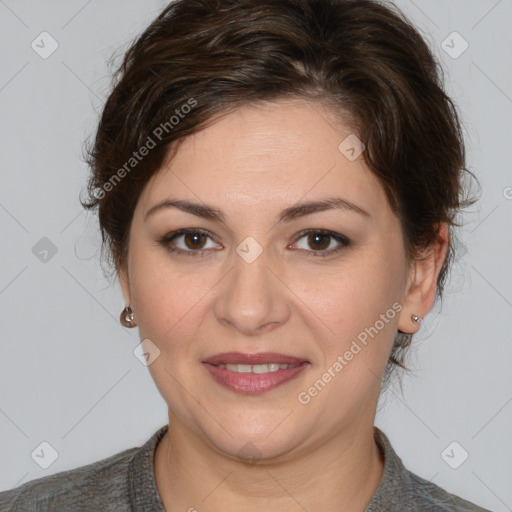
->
<box><xmin>214</xmin><ymin>244</ymin><xmax>289</xmax><ymax>336</ymax></box>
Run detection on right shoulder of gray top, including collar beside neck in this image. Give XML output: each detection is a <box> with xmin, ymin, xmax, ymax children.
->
<box><xmin>365</xmin><ymin>427</ymin><xmax>490</xmax><ymax>512</ymax></box>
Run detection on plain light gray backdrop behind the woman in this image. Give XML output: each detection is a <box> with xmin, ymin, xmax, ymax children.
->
<box><xmin>0</xmin><ymin>0</ymin><xmax>512</xmax><ymax>511</ymax></box>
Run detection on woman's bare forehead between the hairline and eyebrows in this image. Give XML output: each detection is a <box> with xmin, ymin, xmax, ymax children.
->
<box><xmin>139</xmin><ymin>100</ymin><xmax>387</xmax><ymax>218</ymax></box>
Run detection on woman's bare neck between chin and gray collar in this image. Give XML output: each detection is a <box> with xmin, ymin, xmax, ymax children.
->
<box><xmin>155</xmin><ymin>418</ymin><xmax>384</xmax><ymax>512</ymax></box>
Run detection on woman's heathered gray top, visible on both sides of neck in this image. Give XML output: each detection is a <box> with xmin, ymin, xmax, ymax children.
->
<box><xmin>0</xmin><ymin>425</ymin><xmax>490</xmax><ymax>512</ymax></box>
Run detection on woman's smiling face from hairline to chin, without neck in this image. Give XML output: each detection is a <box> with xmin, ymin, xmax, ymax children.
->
<box><xmin>121</xmin><ymin>100</ymin><xmax>421</xmax><ymax>458</ymax></box>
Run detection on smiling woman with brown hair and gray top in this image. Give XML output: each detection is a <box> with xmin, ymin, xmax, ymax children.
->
<box><xmin>0</xmin><ymin>0</ymin><xmax>492</xmax><ymax>511</ymax></box>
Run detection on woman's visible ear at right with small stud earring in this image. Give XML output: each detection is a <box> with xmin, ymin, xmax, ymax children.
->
<box><xmin>398</xmin><ymin>223</ymin><xmax>450</xmax><ymax>334</ymax></box>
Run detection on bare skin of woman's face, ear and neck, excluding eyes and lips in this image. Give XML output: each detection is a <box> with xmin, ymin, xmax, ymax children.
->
<box><xmin>118</xmin><ymin>99</ymin><xmax>448</xmax><ymax>511</ymax></box>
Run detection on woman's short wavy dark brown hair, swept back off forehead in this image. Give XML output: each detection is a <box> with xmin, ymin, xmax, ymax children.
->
<box><xmin>82</xmin><ymin>0</ymin><xmax>476</xmax><ymax>382</ymax></box>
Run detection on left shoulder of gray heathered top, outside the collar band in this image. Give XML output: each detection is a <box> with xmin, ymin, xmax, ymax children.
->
<box><xmin>0</xmin><ymin>448</ymin><xmax>139</xmax><ymax>512</ymax></box>
